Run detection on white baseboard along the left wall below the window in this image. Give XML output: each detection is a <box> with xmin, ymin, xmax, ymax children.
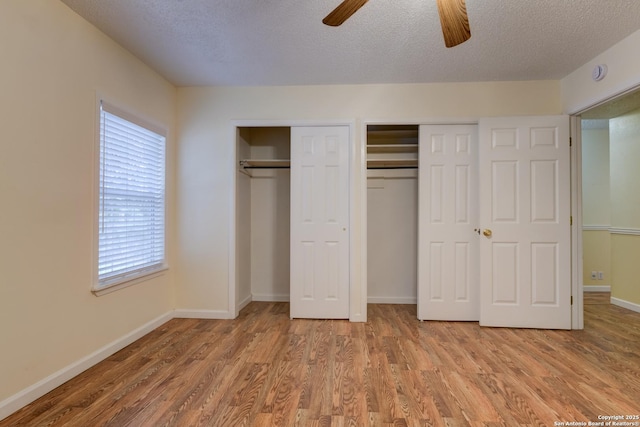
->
<box><xmin>0</xmin><ymin>312</ymin><xmax>173</xmax><ymax>420</ymax></box>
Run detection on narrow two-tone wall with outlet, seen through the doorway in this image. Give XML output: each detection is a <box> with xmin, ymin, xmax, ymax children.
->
<box><xmin>582</xmin><ymin>127</ymin><xmax>611</xmax><ymax>286</ymax></box>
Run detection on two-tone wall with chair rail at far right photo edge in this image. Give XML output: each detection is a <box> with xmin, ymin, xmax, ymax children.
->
<box><xmin>609</xmin><ymin>110</ymin><xmax>640</xmax><ymax>304</ymax></box>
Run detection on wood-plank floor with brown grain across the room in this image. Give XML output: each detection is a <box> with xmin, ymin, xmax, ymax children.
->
<box><xmin>0</xmin><ymin>294</ymin><xmax>640</xmax><ymax>427</ymax></box>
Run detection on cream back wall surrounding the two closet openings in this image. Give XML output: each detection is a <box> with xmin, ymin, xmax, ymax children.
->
<box><xmin>177</xmin><ymin>81</ymin><xmax>561</xmax><ymax>316</ymax></box>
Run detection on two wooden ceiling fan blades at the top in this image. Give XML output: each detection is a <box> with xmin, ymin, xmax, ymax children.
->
<box><xmin>322</xmin><ymin>0</ymin><xmax>471</xmax><ymax>47</ymax></box>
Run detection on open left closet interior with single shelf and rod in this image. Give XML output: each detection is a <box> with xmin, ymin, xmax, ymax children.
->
<box><xmin>235</xmin><ymin>127</ymin><xmax>291</xmax><ymax>303</ymax></box>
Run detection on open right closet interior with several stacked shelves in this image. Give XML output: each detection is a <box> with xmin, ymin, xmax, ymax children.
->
<box><xmin>367</xmin><ymin>125</ymin><xmax>419</xmax><ymax>304</ymax></box>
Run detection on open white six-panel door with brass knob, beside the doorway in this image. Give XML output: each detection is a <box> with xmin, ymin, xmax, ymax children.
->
<box><xmin>479</xmin><ymin>116</ymin><xmax>571</xmax><ymax>329</ymax></box>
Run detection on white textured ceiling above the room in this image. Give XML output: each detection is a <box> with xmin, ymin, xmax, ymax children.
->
<box><xmin>61</xmin><ymin>0</ymin><xmax>640</xmax><ymax>86</ymax></box>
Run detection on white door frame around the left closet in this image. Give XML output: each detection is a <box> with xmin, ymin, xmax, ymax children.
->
<box><xmin>224</xmin><ymin>119</ymin><xmax>358</xmax><ymax>322</ymax></box>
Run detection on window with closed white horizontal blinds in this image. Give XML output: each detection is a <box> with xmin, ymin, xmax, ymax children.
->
<box><xmin>94</xmin><ymin>102</ymin><xmax>166</xmax><ymax>291</ymax></box>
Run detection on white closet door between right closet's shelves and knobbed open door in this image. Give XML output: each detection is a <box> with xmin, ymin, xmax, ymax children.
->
<box><xmin>418</xmin><ymin>125</ymin><xmax>480</xmax><ymax>321</ymax></box>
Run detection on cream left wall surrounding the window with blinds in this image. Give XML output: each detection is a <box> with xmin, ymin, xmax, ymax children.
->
<box><xmin>0</xmin><ymin>0</ymin><xmax>176</xmax><ymax>406</ymax></box>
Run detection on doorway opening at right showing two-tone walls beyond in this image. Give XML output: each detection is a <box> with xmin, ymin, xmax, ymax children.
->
<box><xmin>581</xmin><ymin>89</ymin><xmax>640</xmax><ymax>312</ymax></box>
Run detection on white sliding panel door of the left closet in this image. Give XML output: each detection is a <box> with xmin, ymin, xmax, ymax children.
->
<box><xmin>291</xmin><ymin>126</ymin><xmax>349</xmax><ymax>319</ymax></box>
